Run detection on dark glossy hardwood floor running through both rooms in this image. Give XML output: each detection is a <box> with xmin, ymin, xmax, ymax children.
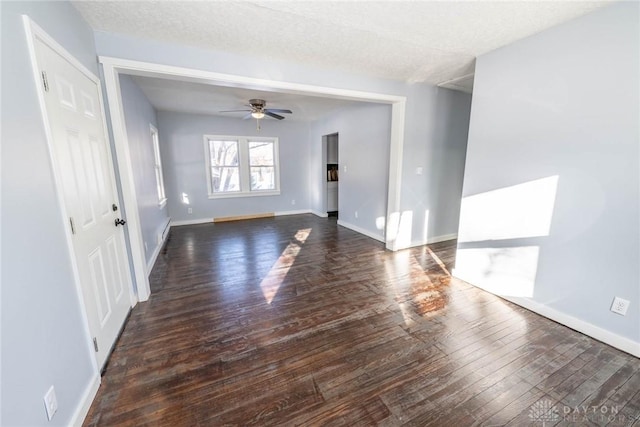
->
<box><xmin>85</xmin><ymin>215</ymin><xmax>640</xmax><ymax>426</ymax></box>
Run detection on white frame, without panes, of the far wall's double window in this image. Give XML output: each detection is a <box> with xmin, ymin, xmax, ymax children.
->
<box><xmin>204</xmin><ymin>135</ymin><xmax>280</xmax><ymax>199</ymax></box>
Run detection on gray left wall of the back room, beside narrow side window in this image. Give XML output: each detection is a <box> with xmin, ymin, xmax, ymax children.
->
<box><xmin>120</xmin><ymin>75</ymin><xmax>169</xmax><ymax>265</ymax></box>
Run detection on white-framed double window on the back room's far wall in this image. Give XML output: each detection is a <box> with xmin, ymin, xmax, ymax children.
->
<box><xmin>204</xmin><ymin>135</ymin><xmax>280</xmax><ymax>198</ymax></box>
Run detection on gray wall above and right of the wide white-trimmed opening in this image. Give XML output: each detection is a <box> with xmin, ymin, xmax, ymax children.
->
<box><xmin>95</xmin><ymin>31</ymin><xmax>476</xmax><ymax>251</ymax></box>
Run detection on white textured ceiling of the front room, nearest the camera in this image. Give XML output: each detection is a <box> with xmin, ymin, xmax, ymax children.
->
<box><xmin>74</xmin><ymin>1</ymin><xmax>608</xmax><ymax>89</ymax></box>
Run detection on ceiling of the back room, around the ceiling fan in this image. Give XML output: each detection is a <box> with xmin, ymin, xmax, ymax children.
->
<box><xmin>132</xmin><ymin>76</ymin><xmax>362</xmax><ymax>121</ymax></box>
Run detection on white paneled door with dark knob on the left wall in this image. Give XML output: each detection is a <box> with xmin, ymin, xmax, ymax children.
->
<box><xmin>35</xmin><ymin>39</ymin><xmax>131</xmax><ymax>368</ymax></box>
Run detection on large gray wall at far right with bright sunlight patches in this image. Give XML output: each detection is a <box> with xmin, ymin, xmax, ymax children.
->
<box><xmin>456</xmin><ymin>2</ymin><xmax>640</xmax><ymax>348</ymax></box>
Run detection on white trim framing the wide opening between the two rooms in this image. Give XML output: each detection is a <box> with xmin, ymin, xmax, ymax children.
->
<box><xmin>99</xmin><ymin>56</ymin><xmax>406</xmax><ymax>301</ymax></box>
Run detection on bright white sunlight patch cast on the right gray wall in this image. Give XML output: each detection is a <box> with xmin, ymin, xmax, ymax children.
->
<box><xmin>453</xmin><ymin>175</ymin><xmax>558</xmax><ymax>297</ymax></box>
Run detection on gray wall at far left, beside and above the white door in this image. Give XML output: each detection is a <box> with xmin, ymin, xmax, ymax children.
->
<box><xmin>0</xmin><ymin>2</ymin><xmax>97</xmax><ymax>426</ymax></box>
